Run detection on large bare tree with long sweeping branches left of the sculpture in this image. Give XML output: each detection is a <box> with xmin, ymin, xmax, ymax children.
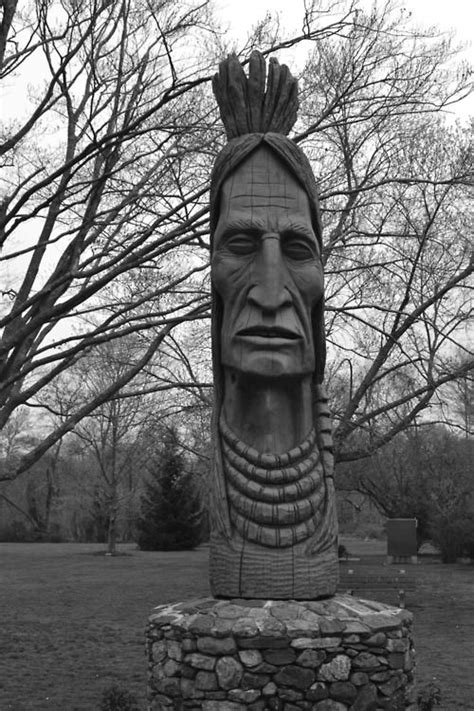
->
<box><xmin>0</xmin><ymin>0</ymin><xmax>356</xmax><ymax>478</ymax></box>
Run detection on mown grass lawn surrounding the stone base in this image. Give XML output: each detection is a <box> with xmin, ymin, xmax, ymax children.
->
<box><xmin>0</xmin><ymin>540</ymin><xmax>474</xmax><ymax>711</ymax></box>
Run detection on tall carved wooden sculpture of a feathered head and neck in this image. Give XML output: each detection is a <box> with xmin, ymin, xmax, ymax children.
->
<box><xmin>210</xmin><ymin>52</ymin><xmax>338</xmax><ymax>599</ymax></box>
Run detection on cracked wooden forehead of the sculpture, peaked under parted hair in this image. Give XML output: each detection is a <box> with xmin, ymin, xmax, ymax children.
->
<box><xmin>219</xmin><ymin>147</ymin><xmax>311</xmax><ymax>228</ymax></box>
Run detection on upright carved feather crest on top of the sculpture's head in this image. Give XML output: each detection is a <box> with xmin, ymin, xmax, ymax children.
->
<box><xmin>212</xmin><ymin>50</ymin><xmax>299</xmax><ymax>140</ymax></box>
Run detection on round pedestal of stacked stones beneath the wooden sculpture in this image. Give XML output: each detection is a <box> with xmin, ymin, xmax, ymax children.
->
<box><xmin>147</xmin><ymin>595</ymin><xmax>417</xmax><ymax>711</ymax></box>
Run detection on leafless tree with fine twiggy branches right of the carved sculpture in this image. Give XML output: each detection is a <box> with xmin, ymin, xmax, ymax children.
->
<box><xmin>297</xmin><ymin>2</ymin><xmax>474</xmax><ymax>460</ymax></box>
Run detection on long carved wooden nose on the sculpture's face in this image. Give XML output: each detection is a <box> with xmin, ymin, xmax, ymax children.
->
<box><xmin>248</xmin><ymin>234</ymin><xmax>291</xmax><ymax>311</ymax></box>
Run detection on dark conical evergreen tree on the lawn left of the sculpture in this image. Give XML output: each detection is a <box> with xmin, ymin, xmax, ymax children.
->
<box><xmin>137</xmin><ymin>429</ymin><xmax>202</xmax><ymax>551</ymax></box>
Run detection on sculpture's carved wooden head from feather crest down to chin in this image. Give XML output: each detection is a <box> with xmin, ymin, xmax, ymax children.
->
<box><xmin>211</xmin><ymin>52</ymin><xmax>325</xmax><ymax>388</ymax></box>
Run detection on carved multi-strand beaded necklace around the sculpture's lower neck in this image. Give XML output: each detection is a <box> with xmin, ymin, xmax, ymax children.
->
<box><xmin>219</xmin><ymin>417</ymin><xmax>325</xmax><ymax>548</ymax></box>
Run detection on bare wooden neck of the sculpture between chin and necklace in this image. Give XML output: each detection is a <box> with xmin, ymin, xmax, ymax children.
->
<box><xmin>223</xmin><ymin>369</ymin><xmax>313</xmax><ymax>454</ymax></box>
